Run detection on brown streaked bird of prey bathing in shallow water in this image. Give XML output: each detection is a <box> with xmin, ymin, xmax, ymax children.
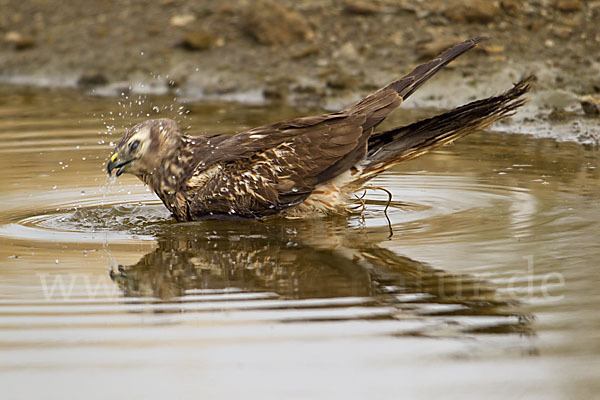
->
<box><xmin>107</xmin><ymin>37</ymin><xmax>533</xmax><ymax>222</ymax></box>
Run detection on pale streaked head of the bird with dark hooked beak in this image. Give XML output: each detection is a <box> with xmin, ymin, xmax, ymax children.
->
<box><xmin>106</xmin><ymin>118</ymin><xmax>181</xmax><ymax>177</ymax></box>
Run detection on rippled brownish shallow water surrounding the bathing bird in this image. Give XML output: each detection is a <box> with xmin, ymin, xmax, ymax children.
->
<box><xmin>0</xmin><ymin>88</ymin><xmax>600</xmax><ymax>399</ymax></box>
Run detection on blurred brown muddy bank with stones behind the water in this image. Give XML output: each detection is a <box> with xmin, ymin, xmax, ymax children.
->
<box><xmin>0</xmin><ymin>0</ymin><xmax>600</xmax><ymax>143</ymax></box>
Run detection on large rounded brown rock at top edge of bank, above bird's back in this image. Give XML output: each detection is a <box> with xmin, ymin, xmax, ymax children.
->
<box><xmin>242</xmin><ymin>1</ymin><xmax>313</xmax><ymax>46</ymax></box>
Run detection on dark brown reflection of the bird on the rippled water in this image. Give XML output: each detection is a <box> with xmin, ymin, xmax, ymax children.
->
<box><xmin>111</xmin><ymin>218</ymin><xmax>532</xmax><ymax>334</ymax></box>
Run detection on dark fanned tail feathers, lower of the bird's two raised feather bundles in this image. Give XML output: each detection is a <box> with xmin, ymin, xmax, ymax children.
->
<box><xmin>352</xmin><ymin>77</ymin><xmax>532</xmax><ymax>188</ymax></box>
